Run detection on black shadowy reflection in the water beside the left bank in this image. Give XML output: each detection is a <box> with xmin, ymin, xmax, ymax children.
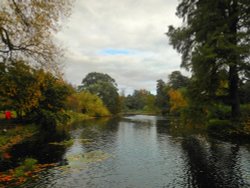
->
<box><xmin>0</xmin><ymin>130</ymin><xmax>69</xmax><ymax>172</ymax></box>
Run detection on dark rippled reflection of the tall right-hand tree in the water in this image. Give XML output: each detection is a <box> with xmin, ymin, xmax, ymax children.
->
<box><xmin>182</xmin><ymin>136</ymin><xmax>244</xmax><ymax>187</ymax></box>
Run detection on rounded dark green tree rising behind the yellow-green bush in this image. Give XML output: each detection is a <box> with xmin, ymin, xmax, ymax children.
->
<box><xmin>79</xmin><ymin>72</ymin><xmax>120</xmax><ymax>114</ymax></box>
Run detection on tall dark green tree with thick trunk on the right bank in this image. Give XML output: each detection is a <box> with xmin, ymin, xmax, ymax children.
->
<box><xmin>167</xmin><ymin>0</ymin><xmax>250</xmax><ymax>118</ymax></box>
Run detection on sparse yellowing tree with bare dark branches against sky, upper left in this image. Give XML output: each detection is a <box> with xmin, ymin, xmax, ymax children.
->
<box><xmin>0</xmin><ymin>0</ymin><xmax>71</xmax><ymax>71</ymax></box>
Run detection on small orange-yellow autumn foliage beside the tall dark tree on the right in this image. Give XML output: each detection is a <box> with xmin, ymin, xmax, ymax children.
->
<box><xmin>168</xmin><ymin>89</ymin><xmax>188</xmax><ymax>112</ymax></box>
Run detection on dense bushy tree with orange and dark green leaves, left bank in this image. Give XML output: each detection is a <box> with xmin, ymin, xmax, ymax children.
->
<box><xmin>0</xmin><ymin>61</ymin><xmax>71</xmax><ymax>126</ymax></box>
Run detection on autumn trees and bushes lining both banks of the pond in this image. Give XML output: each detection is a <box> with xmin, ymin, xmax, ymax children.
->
<box><xmin>0</xmin><ymin>0</ymin><xmax>250</xmax><ymax>187</ymax></box>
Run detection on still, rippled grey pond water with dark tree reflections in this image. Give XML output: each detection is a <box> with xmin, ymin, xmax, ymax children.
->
<box><xmin>3</xmin><ymin>115</ymin><xmax>250</xmax><ymax>188</ymax></box>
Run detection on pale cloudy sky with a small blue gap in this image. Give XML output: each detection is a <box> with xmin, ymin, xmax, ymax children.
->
<box><xmin>56</xmin><ymin>0</ymin><xmax>184</xmax><ymax>93</ymax></box>
